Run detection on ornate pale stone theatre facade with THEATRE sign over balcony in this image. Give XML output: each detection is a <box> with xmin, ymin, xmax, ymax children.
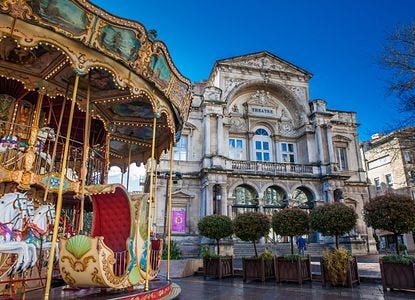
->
<box><xmin>153</xmin><ymin>52</ymin><xmax>373</xmax><ymax>252</ymax></box>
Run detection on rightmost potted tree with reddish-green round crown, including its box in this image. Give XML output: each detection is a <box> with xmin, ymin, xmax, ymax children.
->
<box><xmin>364</xmin><ymin>193</ymin><xmax>415</xmax><ymax>291</ymax></box>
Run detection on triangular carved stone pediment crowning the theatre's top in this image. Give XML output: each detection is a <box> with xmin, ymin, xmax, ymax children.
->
<box><xmin>217</xmin><ymin>52</ymin><xmax>312</xmax><ymax>79</ymax></box>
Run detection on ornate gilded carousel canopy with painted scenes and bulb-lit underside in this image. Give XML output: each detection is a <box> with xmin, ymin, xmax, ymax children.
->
<box><xmin>0</xmin><ymin>0</ymin><xmax>190</xmax><ymax>161</ymax></box>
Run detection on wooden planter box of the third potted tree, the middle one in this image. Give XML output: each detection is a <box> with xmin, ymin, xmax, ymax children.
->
<box><xmin>276</xmin><ymin>256</ymin><xmax>312</xmax><ymax>284</ymax></box>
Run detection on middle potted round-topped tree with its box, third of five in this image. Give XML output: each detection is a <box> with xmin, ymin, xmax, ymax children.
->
<box><xmin>271</xmin><ymin>208</ymin><xmax>311</xmax><ymax>284</ymax></box>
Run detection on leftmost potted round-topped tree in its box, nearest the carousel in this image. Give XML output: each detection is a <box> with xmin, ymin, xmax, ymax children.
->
<box><xmin>197</xmin><ymin>215</ymin><xmax>233</xmax><ymax>279</ymax></box>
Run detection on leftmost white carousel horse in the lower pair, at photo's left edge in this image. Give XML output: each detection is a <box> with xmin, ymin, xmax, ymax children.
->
<box><xmin>0</xmin><ymin>192</ymin><xmax>37</xmax><ymax>273</ymax></box>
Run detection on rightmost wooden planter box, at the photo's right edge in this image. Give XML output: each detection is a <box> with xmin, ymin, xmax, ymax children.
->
<box><xmin>379</xmin><ymin>260</ymin><xmax>415</xmax><ymax>291</ymax></box>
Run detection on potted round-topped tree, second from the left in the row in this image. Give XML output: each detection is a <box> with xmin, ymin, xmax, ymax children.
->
<box><xmin>233</xmin><ymin>212</ymin><xmax>275</xmax><ymax>282</ymax></box>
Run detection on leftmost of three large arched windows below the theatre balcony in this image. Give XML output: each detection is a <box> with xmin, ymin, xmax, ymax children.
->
<box><xmin>232</xmin><ymin>184</ymin><xmax>258</xmax><ymax>217</ymax></box>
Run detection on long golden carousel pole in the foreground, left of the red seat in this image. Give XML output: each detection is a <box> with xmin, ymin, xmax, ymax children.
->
<box><xmin>44</xmin><ymin>73</ymin><xmax>79</xmax><ymax>300</ymax></box>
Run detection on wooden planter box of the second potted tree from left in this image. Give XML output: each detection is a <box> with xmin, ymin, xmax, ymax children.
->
<box><xmin>242</xmin><ymin>257</ymin><xmax>276</xmax><ymax>282</ymax></box>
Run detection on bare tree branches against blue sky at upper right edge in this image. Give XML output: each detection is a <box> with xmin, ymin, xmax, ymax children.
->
<box><xmin>381</xmin><ymin>21</ymin><xmax>415</xmax><ymax>119</ymax></box>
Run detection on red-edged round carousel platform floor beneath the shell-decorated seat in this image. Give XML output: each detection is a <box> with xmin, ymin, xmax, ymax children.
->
<box><xmin>21</xmin><ymin>280</ymin><xmax>181</xmax><ymax>300</ymax></box>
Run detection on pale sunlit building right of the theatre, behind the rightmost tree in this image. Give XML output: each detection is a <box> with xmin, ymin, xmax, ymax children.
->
<box><xmin>361</xmin><ymin>127</ymin><xmax>415</xmax><ymax>251</ymax></box>
